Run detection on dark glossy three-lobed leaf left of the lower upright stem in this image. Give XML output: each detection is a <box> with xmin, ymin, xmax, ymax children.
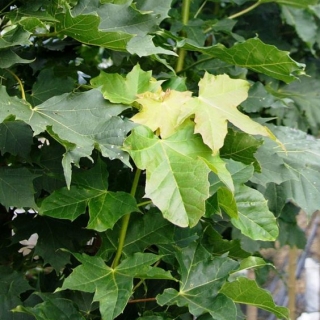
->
<box><xmin>40</xmin><ymin>160</ymin><xmax>139</xmax><ymax>232</ymax></box>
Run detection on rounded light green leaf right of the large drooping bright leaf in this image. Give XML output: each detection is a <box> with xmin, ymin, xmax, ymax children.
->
<box><xmin>231</xmin><ymin>186</ymin><xmax>278</xmax><ymax>241</ymax></box>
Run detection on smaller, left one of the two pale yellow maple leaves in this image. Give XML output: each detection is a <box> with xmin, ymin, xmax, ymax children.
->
<box><xmin>131</xmin><ymin>90</ymin><xmax>192</xmax><ymax>138</ymax></box>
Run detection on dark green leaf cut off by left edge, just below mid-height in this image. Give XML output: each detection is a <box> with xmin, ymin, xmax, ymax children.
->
<box><xmin>0</xmin><ymin>167</ymin><xmax>38</xmax><ymax>209</ymax></box>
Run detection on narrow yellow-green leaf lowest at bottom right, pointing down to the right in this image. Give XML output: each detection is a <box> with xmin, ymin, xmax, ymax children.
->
<box><xmin>220</xmin><ymin>277</ymin><xmax>289</xmax><ymax>319</ymax></box>
